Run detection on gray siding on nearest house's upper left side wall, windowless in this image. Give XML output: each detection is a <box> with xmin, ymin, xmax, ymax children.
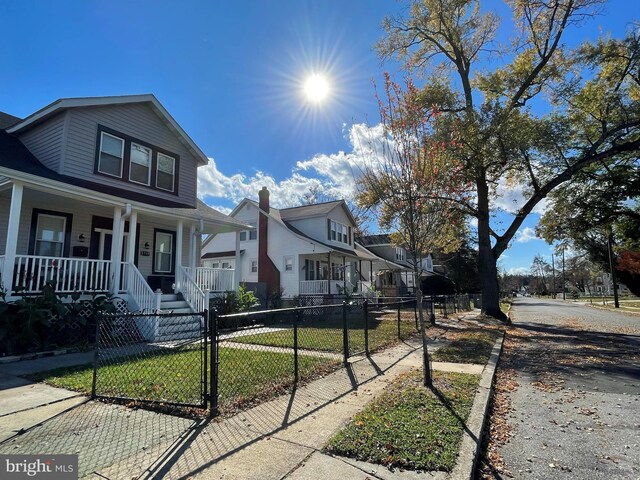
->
<box><xmin>19</xmin><ymin>113</ymin><xmax>66</xmax><ymax>173</ymax></box>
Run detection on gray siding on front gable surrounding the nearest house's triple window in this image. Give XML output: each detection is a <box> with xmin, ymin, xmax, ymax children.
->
<box><xmin>61</xmin><ymin>104</ymin><xmax>197</xmax><ymax>206</ymax></box>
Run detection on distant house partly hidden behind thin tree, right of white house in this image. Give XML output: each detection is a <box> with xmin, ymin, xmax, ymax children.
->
<box><xmin>357</xmin><ymin>234</ymin><xmax>433</xmax><ymax>297</ymax></box>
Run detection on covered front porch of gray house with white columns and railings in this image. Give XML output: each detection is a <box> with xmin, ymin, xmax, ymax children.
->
<box><xmin>0</xmin><ymin>180</ymin><xmax>241</xmax><ymax>311</ymax></box>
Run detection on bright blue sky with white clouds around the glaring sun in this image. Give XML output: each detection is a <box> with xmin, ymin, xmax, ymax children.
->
<box><xmin>0</xmin><ymin>0</ymin><xmax>640</xmax><ymax>271</ymax></box>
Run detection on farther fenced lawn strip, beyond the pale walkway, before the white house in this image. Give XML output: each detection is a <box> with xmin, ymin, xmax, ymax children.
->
<box><xmin>230</xmin><ymin>310</ymin><xmax>416</xmax><ymax>353</ymax></box>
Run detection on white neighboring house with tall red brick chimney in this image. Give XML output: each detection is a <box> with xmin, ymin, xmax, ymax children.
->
<box><xmin>202</xmin><ymin>187</ymin><xmax>383</xmax><ymax>299</ymax></box>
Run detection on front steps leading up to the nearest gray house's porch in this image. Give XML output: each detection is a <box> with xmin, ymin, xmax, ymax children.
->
<box><xmin>155</xmin><ymin>294</ymin><xmax>202</xmax><ymax>342</ymax></box>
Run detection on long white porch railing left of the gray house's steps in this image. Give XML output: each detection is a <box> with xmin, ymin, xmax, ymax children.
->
<box><xmin>11</xmin><ymin>255</ymin><xmax>111</xmax><ymax>293</ymax></box>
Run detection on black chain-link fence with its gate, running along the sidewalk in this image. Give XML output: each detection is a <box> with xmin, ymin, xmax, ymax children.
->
<box><xmin>93</xmin><ymin>295</ymin><xmax>470</xmax><ymax>414</ymax></box>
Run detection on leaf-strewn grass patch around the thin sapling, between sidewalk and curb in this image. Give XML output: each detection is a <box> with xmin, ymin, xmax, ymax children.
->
<box><xmin>325</xmin><ymin>370</ymin><xmax>479</xmax><ymax>471</ymax></box>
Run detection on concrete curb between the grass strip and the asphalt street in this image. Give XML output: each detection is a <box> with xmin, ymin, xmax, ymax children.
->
<box><xmin>447</xmin><ymin>332</ymin><xmax>505</xmax><ymax>480</ymax></box>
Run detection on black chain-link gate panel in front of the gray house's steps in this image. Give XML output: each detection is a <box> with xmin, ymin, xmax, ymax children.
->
<box><xmin>92</xmin><ymin>312</ymin><xmax>208</xmax><ymax>408</ymax></box>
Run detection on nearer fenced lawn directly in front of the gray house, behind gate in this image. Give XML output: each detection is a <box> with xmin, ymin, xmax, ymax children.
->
<box><xmin>31</xmin><ymin>348</ymin><xmax>339</xmax><ymax>408</ymax></box>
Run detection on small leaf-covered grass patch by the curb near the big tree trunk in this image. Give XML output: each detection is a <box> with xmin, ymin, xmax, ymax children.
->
<box><xmin>432</xmin><ymin>330</ymin><xmax>499</xmax><ymax>364</ymax></box>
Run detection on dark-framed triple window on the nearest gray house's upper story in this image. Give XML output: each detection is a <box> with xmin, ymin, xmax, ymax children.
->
<box><xmin>95</xmin><ymin>126</ymin><xmax>180</xmax><ymax>194</ymax></box>
